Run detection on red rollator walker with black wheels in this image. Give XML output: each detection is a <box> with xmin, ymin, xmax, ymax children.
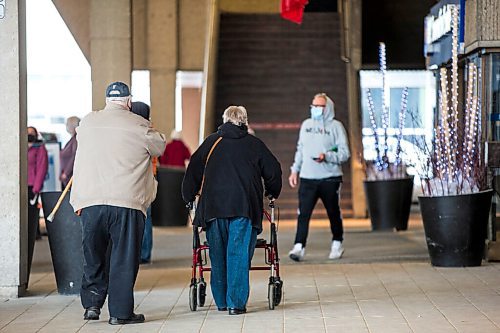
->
<box><xmin>189</xmin><ymin>199</ymin><xmax>283</xmax><ymax>311</ymax></box>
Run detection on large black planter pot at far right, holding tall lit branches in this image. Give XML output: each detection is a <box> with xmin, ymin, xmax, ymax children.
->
<box><xmin>418</xmin><ymin>190</ymin><xmax>493</xmax><ymax>267</ymax></box>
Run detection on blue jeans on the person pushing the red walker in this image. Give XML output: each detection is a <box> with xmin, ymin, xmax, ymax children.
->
<box><xmin>207</xmin><ymin>217</ymin><xmax>257</xmax><ymax>310</ymax></box>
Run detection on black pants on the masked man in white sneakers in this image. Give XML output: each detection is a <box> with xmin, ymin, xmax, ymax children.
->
<box><xmin>295</xmin><ymin>177</ymin><xmax>344</xmax><ymax>247</ymax></box>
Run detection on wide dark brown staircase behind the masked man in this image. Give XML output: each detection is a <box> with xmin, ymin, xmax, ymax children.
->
<box><xmin>215</xmin><ymin>12</ymin><xmax>352</xmax><ymax>218</ymax></box>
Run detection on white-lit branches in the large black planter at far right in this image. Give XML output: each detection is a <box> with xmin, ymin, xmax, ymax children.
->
<box><xmin>422</xmin><ymin>5</ymin><xmax>487</xmax><ymax>196</ymax></box>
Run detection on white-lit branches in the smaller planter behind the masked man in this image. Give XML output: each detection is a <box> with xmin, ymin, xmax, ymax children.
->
<box><xmin>365</xmin><ymin>43</ymin><xmax>408</xmax><ymax>180</ymax></box>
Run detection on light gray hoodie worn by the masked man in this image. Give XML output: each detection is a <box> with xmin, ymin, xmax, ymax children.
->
<box><xmin>291</xmin><ymin>97</ymin><xmax>351</xmax><ymax>179</ymax></box>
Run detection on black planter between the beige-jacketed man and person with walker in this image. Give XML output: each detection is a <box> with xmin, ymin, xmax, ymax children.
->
<box><xmin>151</xmin><ymin>167</ymin><xmax>189</xmax><ymax>226</ymax></box>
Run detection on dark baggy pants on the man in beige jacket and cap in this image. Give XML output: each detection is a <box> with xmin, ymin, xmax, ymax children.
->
<box><xmin>80</xmin><ymin>205</ymin><xmax>145</xmax><ymax>319</ymax></box>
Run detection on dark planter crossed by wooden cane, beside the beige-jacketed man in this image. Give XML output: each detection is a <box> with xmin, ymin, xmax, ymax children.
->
<box><xmin>42</xmin><ymin>192</ymin><xmax>83</xmax><ymax>295</ymax></box>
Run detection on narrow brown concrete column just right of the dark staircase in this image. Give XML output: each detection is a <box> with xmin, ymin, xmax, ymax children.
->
<box><xmin>340</xmin><ymin>0</ymin><xmax>366</xmax><ymax>217</ymax></box>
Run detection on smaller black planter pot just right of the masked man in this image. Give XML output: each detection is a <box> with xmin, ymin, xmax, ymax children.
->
<box><xmin>364</xmin><ymin>176</ymin><xmax>413</xmax><ymax>231</ymax></box>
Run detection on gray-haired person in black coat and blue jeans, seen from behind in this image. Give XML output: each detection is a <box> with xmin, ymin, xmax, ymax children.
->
<box><xmin>182</xmin><ymin>106</ymin><xmax>282</xmax><ymax>315</ymax></box>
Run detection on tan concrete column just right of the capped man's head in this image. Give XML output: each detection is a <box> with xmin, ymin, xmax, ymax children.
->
<box><xmin>147</xmin><ymin>0</ymin><xmax>178</xmax><ymax>135</ymax></box>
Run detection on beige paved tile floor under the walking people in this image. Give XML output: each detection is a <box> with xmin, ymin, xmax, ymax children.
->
<box><xmin>0</xmin><ymin>211</ymin><xmax>500</xmax><ymax>333</ymax></box>
